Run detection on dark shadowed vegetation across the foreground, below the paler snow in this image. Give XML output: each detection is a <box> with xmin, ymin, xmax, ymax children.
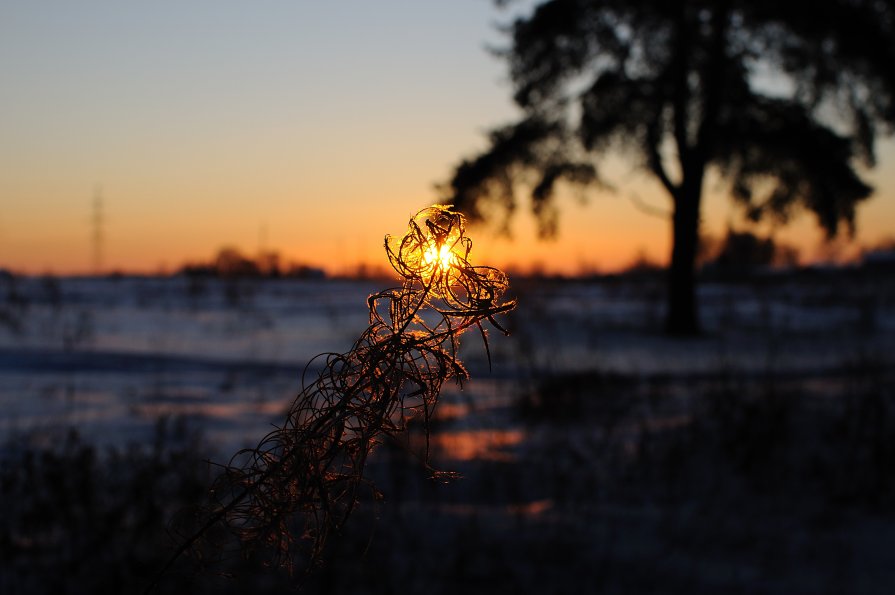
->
<box><xmin>0</xmin><ymin>360</ymin><xmax>895</xmax><ymax>594</ymax></box>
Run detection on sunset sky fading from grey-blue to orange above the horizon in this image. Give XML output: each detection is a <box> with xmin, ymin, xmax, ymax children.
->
<box><xmin>0</xmin><ymin>0</ymin><xmax>895</xmax><ymax>274</ymax></box>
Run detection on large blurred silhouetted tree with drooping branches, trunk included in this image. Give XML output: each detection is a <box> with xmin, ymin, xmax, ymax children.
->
<box><xmin>443</xmin><ymin>0</ymin><xmax>895</xmax><ymax>334</ymax></box>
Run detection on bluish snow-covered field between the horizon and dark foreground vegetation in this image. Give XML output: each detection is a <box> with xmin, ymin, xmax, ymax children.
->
<box><xmin>0</xmin><ymin>278</ymin><xmax>895</xmax><ymax>456</ymax></box>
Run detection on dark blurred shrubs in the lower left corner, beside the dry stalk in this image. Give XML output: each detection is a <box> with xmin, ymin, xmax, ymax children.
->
<box><xmin>0</xmin><ymin>420</ymin><xmax>208</xmax><ymax>595</ymax></box>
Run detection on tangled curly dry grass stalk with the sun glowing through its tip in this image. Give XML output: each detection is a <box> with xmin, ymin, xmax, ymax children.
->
<box><xmin>150</xmin><ymin>206</ymin><xmax>515</xmax><ymax>589</ymax></box>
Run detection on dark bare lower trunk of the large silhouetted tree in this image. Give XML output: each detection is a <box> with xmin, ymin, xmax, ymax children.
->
<box><xmin>665</xmin><ymin>184</ymin><xmax>702</xmax><ymax>337</ymax></box>
